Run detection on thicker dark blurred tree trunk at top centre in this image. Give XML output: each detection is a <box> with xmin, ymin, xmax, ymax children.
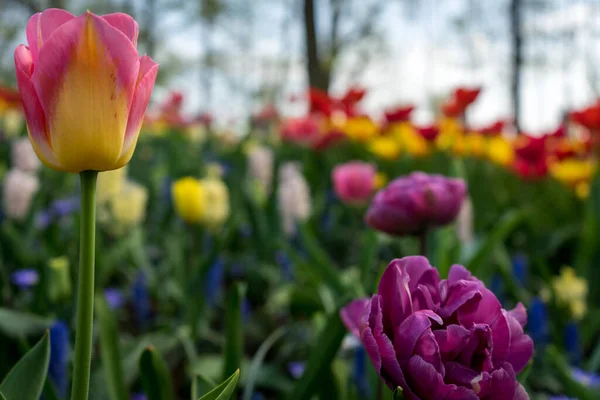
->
<box><xmin>304</xmin><ymin>0</ymin><xmax>329</xmax><ymax>91</ymax></box>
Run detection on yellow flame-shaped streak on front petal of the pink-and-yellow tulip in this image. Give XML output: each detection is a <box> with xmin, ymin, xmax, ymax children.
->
<box><xmin>49</xmin><ymin>17</ymin><xmax>129</xmax><ymax>172</ymax></box>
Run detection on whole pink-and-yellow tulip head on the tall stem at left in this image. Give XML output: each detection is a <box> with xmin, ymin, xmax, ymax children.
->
<box><xmin>15</xmin><ymin>9</ymin><xmax>158</xmax><ymax>173</ymax></box>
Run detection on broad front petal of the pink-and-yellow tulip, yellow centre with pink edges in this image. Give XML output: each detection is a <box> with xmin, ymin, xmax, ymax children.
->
<box><xmin>32</xmin><ymin>12</ymin><xmax>139</xmax><ymax>172</ymax></box>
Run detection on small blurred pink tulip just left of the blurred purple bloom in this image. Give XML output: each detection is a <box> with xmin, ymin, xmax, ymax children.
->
<box><xmin>331</xmin><ymin>161</ymin><xmax>377</xmax><ymax>204</ymax></box>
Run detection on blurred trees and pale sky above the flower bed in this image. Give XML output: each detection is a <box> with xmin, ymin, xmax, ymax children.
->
<box><xmin>0</xmin><ymin>0</ymin><xmax>600</xmax><ymax>131</ymax></box>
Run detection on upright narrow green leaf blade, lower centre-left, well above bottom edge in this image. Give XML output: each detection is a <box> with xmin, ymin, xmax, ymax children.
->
<box><xmin>222</xmin><ymin>283</ymin><xmax>245</xmax><ymax>380</ymax></box>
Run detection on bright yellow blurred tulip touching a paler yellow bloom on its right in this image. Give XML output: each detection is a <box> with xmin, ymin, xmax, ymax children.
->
<box><xmin>171</xmin><ymin>177</ymin><xmax>206</xmax><ymax>224</ymax></box>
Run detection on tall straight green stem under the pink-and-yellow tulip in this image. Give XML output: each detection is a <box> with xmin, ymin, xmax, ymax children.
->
<box><xmin>71</xmin><ymin>171</ymin><xmax>98</xmax><ymax>400</ymax></box>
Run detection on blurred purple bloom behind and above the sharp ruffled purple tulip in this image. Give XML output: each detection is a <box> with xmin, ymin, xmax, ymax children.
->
<box><xmin>366</xmin><ymin>172</ymin><xmax>467</xmax><ymax>235</ymax></box>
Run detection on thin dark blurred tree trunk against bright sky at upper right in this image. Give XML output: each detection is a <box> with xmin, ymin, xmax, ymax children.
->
<box><xmin>510</xmin><ymin>0</ymin><xmax>523</xmax><ymax>133</ymax></box>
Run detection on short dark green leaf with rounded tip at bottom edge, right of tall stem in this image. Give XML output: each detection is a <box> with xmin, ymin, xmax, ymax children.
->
<box><xmin>140</xmin><ymin>347</ymin><xmax>175</xmax><ymax>400</ymax></box>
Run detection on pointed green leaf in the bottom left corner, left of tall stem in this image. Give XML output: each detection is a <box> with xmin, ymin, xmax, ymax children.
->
<box><xmin>0</xmin><ymin>332</ymin><xmax>50</xmax><ymax>400</ymax></box>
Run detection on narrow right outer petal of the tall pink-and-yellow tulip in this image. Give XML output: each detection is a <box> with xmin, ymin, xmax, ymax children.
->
<box><xmin>116</xmin><ymin>56</ymin><xmax>158</xmax><ymax>168</ymax></box>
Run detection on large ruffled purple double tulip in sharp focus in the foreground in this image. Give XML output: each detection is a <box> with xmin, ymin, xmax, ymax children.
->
<box><xmin>341</xmin><ymin>256</ymin><xmax>533</xmax><ymax>400</ymax></box>
